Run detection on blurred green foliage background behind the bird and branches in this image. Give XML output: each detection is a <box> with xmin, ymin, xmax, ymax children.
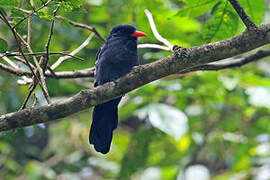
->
<box><xmin>0</xmin><ymin>0</ymin><xmax>270</xmax><ymax>180</ymax></box>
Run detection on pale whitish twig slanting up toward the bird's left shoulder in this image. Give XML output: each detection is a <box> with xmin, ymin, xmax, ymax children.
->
<box><xmin>51</xmin><ymin>33</ymin><xmax>95</xmax><ymax>70</ymax></box>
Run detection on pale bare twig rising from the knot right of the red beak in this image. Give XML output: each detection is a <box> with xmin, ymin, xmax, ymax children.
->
<box><xmin>144</xmin><ymin>9</ymin><xmax>173</xmax><ymax>50</ymax></box>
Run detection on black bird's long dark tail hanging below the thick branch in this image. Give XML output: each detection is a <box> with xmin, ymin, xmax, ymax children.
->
<box><xmin>89</xmin><ymin>97</ymin><xmax>122</xmax><ymax>154</ymax></box>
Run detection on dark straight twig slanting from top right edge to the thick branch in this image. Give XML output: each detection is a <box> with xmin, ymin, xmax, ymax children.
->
<box><xmin>228</xmin><ymin>0</ymin><xmax>257</xmax><ymax>30</ymax></box>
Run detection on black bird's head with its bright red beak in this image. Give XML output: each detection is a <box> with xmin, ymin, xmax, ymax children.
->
<box><xmin>110</xmin><ymin>24</ymin><xmax>147</xmax><ymax>39</ymax></box>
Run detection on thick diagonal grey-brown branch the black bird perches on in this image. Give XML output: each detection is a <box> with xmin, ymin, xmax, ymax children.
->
<box><xmin>0</xmin><ymin>25</ymin><xmax>270</xmax><ymax>131</ymax></box>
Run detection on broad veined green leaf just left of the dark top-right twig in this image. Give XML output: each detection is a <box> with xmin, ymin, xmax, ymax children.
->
<box><xmin>202</xmin><ymin>1</ymin><xmax>239</xmax><ymax>42</ymax></box>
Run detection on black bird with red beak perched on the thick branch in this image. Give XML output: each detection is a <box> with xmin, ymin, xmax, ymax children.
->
<box><xmin>89</xmin><ymin>24</ymin><xmax>147</xmax><ymax>154</ymax></box>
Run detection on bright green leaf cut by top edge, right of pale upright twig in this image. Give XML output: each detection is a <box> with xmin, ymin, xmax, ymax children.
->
<box><xmin>176</xmin><ymin>0</ymin><xmax>220</xmax><ymax>17</ymax></box>
